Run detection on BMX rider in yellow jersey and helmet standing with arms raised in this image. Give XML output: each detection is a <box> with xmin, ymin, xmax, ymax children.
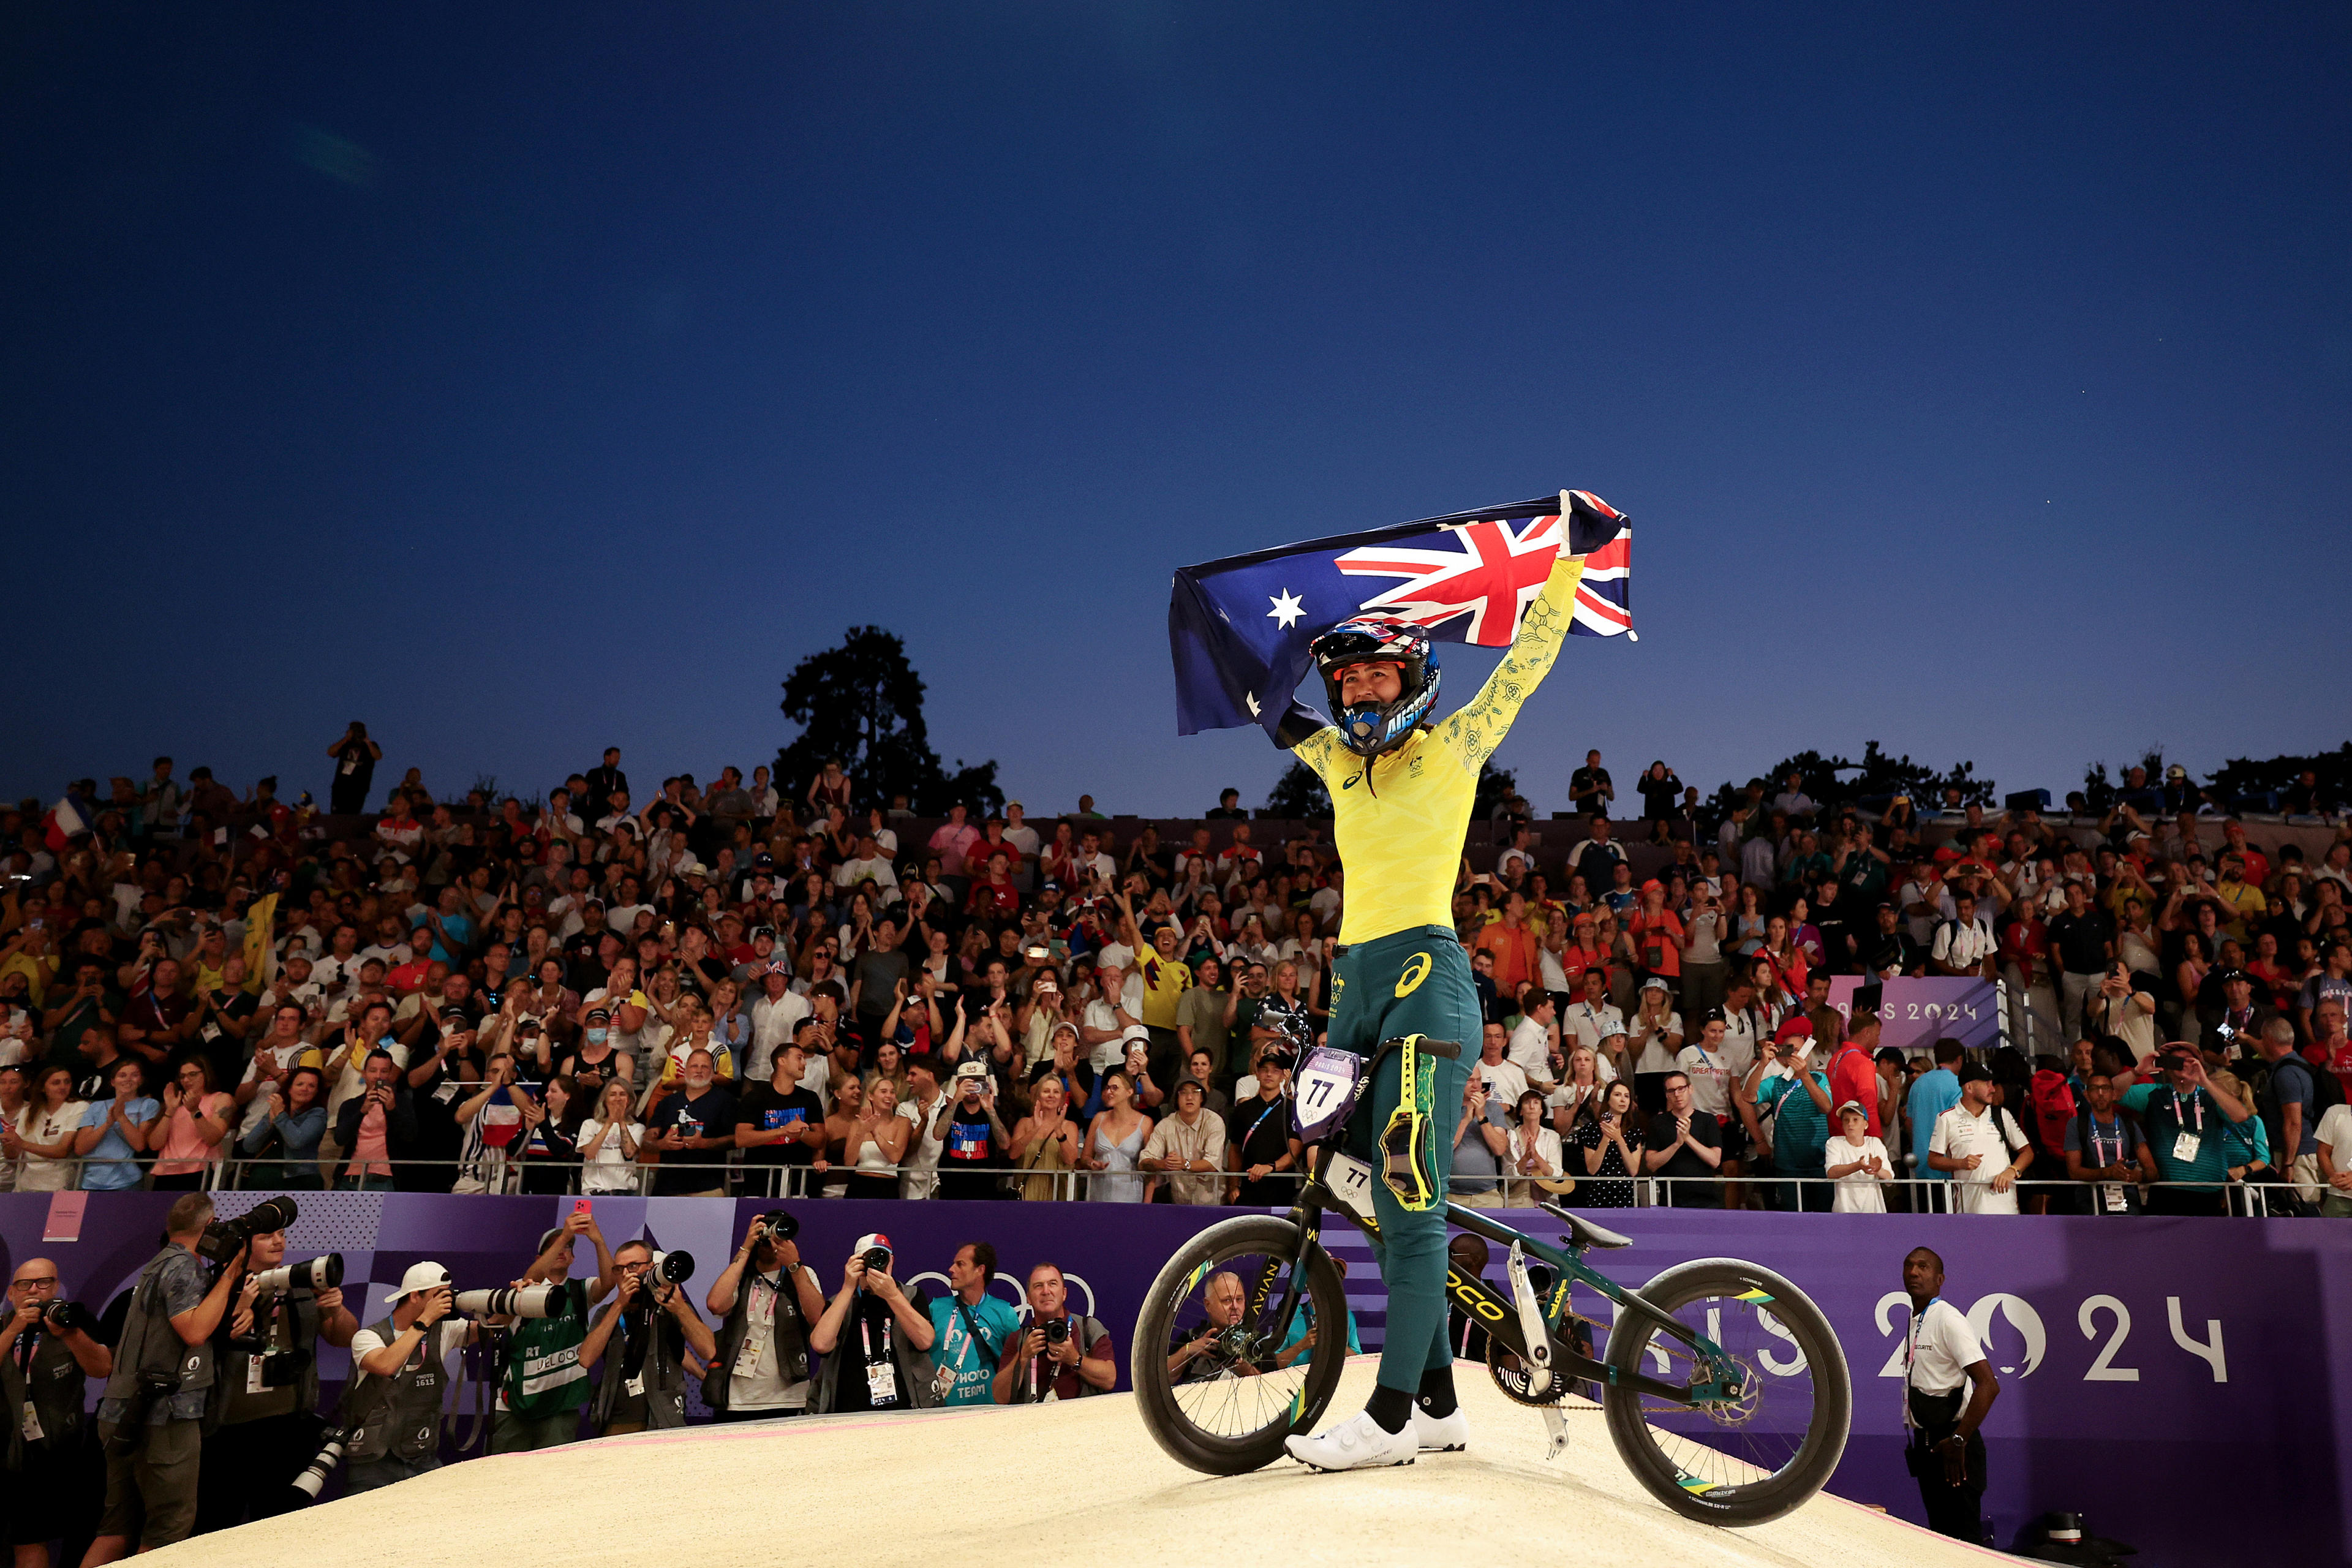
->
<box><xmin>1277</xmin><ymin>543</ymin><xmax>1583</xmax><ymax>1469</ymax></box>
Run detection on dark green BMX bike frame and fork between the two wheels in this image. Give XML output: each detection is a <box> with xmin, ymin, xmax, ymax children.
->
<box><xmin>1249</xmin><ymin>1145</ymin><xmax>1741</xmax><ymax>1408</ymax></box>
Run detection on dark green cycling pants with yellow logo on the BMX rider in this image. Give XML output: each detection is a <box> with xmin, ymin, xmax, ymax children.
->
<box><xmin>1329</xmin><ymin>926</ymin><xmax>1479</xmax><ymax>1394</ymax></box>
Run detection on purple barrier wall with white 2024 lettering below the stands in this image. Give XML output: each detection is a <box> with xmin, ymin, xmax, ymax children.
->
<box><xmin>0</xmin><ymin>1192</ymin><xmax>2352</xmax><ymax>1568</ymax></box>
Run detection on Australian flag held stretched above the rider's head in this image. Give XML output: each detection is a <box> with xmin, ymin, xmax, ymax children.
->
<box><xmin>1169</xmin><ymin>489</ymin><xmax>1632</xmax><ymax>736</ymax></box>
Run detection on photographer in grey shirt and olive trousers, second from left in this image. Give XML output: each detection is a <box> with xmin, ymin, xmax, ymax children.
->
<box><xmin>82</xmin><ymin>1192</ymin><xmax>244</xmax><ymax>1563</ymax></box>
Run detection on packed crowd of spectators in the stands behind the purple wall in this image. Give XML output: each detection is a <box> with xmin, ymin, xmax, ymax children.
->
<box><xmin>0</xmin><ymin>724</ymin><xmax>2352</xmax><ymax>1213</ymax></box>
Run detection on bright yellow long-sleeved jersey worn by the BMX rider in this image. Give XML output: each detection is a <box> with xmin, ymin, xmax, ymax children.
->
<box><xmin>1291</xmin><ymin>555</ymin><xmax>1585</xmax><ymax>945</ymax></box>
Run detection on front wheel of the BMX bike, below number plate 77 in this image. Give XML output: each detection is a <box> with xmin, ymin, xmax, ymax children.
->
<box><xmin>1131</xmin><ymin>1215</ymin><xmax>1348</xmax><ymax>1476</ymax></box>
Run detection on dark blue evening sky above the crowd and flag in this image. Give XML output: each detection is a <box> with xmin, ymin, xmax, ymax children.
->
<box><xmin>0</xmin><ymin>12</ymin><xmax>2352</xmax><ymax>811</ymax></box>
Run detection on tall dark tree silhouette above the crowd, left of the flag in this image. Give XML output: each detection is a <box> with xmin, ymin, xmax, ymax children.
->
<box><xmin>776</xmin><ymin>625</ymin><xmax>1005</xmax><ymax>816</ymax></box>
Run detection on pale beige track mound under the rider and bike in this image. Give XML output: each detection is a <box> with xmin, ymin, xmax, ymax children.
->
<box><xmin>160</xmin><ymin>1357</ymin><xmax>2018</xmax><ymax>1568</ymax></box>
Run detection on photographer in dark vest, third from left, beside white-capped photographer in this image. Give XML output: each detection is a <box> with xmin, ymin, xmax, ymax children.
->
<box><xmin>195</xmin><ymin>1227</ymin><xmax>360</xmax><ymax>1535</ymax></box>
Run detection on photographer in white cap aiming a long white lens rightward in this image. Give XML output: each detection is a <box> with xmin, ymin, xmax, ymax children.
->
<box><xmin>344</xmin><ymin>1262</ymin><xmax>480</xmax><ymax>1498</ymax></box>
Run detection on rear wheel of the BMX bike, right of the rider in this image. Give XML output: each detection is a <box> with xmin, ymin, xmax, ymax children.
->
<box><xmin>1602</xmin><ymin>1257</ymin><xmax>1853</xmax><ymax>1526</ymax></box>
